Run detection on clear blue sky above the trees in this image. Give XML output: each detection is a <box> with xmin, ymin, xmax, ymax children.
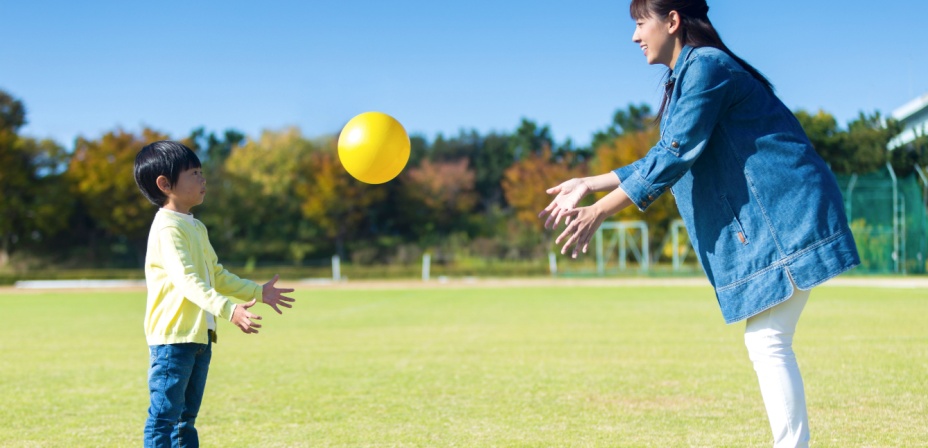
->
<box><xmin>0</xmin><ymin>0</ymin><xmax>928</xmax><ymax>147</ymax></box>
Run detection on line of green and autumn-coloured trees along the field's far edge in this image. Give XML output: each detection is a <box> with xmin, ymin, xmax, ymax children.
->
<box><xmin>0</xmin><ymin>90</ymin><xmax>928</xmax><ymax>269</ymax></box>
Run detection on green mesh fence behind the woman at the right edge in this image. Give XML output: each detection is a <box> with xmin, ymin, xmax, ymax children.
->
<box><xmin>837</xmin><ymin>168</ymin><xmax>928</xmax><ymax>274</ymax></box>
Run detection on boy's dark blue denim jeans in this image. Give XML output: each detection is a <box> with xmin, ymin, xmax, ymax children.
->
<box><xmin>145</xmin><ymin>343</ymin><xmax>212</xmax><ymax>448</ymax></box>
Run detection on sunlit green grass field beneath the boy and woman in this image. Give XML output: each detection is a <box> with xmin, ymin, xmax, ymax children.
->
<box><xmin>0</xmin><ymin>286</ymin><xmax>928</xmax><ymax>447</ymax></box>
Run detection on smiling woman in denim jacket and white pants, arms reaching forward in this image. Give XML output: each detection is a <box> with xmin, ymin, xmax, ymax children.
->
<box><xmin>540</xmin><ymin>0</ymin><xmax>860</xmax><ymax>447</ymax></box>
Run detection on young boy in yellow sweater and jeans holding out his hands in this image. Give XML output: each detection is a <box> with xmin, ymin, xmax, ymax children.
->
<box><xmin>135</xmin><ymin>141</ymin><xmax>294</xmax><ymax>447</ymax></box>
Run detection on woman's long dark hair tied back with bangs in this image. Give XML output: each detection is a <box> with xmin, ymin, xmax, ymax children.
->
<box><xmin>629</xmin><ymin>0</ymin><xmax>773</xmax><ymax>121</ymax></box>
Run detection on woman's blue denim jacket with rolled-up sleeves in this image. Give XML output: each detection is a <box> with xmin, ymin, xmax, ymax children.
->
<box><xmin>615</xmin><ymin>46</ymin><xmax>860</xmax><ymax>323</ymax></box>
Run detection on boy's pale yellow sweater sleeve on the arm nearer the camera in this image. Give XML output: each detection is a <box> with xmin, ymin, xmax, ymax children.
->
<box><xmin>158</xmin><ymin>226</ymin><xmax>234</xmax><ymax>320</ymax></box>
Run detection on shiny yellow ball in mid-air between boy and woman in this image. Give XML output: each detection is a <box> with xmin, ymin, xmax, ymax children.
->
<box><xmin>338</xmin><ymin>112</ymin><xmax>409</xmax><ymax>184</ymax></box>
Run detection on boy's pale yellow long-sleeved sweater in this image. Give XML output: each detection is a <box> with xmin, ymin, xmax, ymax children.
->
<box><xmin>145</xmin><ymin>210</ymin><xmax>262</xmax><ymax>345</ymax></box>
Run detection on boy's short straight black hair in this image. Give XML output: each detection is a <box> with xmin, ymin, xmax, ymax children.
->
<box><xmin>135</xmin><ymin>140</ymin><xmax>201</xmax><ymax>207</ymax></box>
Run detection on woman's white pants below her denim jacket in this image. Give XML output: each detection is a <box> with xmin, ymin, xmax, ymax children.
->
<box><xmin>744</xmin><ymin>285</ymin><xmax>810</xmax><ymax>448</ymax></box>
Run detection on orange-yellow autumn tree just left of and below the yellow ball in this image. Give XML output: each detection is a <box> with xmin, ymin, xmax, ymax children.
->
<box><xmin>296</xmin><ymin>138</ymin><xmax>387</xmax><ymax>257</ymax></box>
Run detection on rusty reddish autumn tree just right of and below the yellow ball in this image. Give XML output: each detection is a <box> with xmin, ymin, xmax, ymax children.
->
<box><xmin>400</xmin><ymin>159</ymin><xmax>477</xmax><ymax>239</ymax></box>
